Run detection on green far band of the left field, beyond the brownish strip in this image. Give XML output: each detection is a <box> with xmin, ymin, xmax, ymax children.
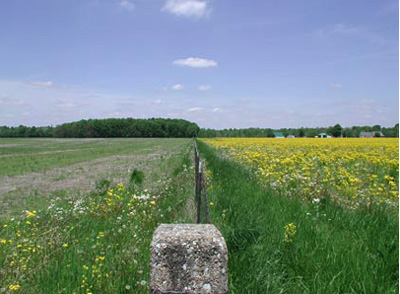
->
<box><xmin>0</xmin><ymin>139</ymin><xmax>187</xmax><ymax>176</ymax></box>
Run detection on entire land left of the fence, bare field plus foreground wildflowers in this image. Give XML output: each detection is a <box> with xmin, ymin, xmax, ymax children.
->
<box><xmin>0</xmin><ymin>139</ymin><xmax>193</xmax><ymax>294</ymax></box>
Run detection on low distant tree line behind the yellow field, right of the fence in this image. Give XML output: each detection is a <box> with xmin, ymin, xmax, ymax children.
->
<box><xmin>198</xmin><ymin>124</ymin><xmax>399</xmax><ymax>138</ymax></box>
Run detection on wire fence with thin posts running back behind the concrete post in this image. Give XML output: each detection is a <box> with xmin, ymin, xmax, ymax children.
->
<box><xmin>194</xmin><ymin>141</ymin><xmax>211</xmax><ymax>224</ymax></box>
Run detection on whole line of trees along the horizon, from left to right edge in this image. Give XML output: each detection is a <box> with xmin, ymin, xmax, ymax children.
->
<box><xmin>0</xmin><ymin>118</ymin><xmax>399</xmax><ymax>138</ymax></box>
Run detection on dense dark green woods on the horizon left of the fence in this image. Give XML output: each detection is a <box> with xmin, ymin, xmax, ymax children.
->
<box><xmin>0</xmin><ymin>118</ymin><xmax>200</xmax><ymax>138</ymax></box>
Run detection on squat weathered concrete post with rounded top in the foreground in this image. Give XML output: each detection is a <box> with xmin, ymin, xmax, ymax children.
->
<box><xmin>149</xmin><ymin>224</ymin><xmax>228</xmax><ymax>294</ymax></box>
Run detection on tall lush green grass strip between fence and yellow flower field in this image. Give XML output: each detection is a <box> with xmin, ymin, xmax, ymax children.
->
<box><xmin>198</xmin><ymin>142</ymin><xmax>399</xmax><ymax>294</ymax></box>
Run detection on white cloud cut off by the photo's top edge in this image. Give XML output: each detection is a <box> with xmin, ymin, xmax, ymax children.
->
<box><xmin>162</xmin><ymin>0</ymin><xmax>210</xmax><ymax>18</ymax></box>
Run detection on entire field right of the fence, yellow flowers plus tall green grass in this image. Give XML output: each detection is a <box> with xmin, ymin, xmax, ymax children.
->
<box><xmin>198</xmin><ymin>138</ymin><xmax>399</xmax><ymax>294</ymax></box>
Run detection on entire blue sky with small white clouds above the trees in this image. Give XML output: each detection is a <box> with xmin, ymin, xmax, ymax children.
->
<box><xmin>0</xmin><ymin>0</ymin><xmax>399</xmax><ymax>129</ymax></box>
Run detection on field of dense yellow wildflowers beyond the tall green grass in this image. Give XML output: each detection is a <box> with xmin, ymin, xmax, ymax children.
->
<box><xmin>203</xmin><ymin>138</ymin><xmax>399</xmax><ymax>208</ymax></box>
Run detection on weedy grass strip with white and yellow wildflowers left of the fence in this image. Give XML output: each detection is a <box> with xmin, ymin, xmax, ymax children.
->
<box><xmin>0</xmin><ymin>142</ymin><xmax>193</xmax><ymax>294</ymax></box>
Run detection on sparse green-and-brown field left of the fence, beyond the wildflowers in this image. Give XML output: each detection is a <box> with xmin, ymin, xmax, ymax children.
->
<box><xmin>0</xmin><ymin>139</ymin><xmax>189</xmax><ymax>216</ymax></box>
